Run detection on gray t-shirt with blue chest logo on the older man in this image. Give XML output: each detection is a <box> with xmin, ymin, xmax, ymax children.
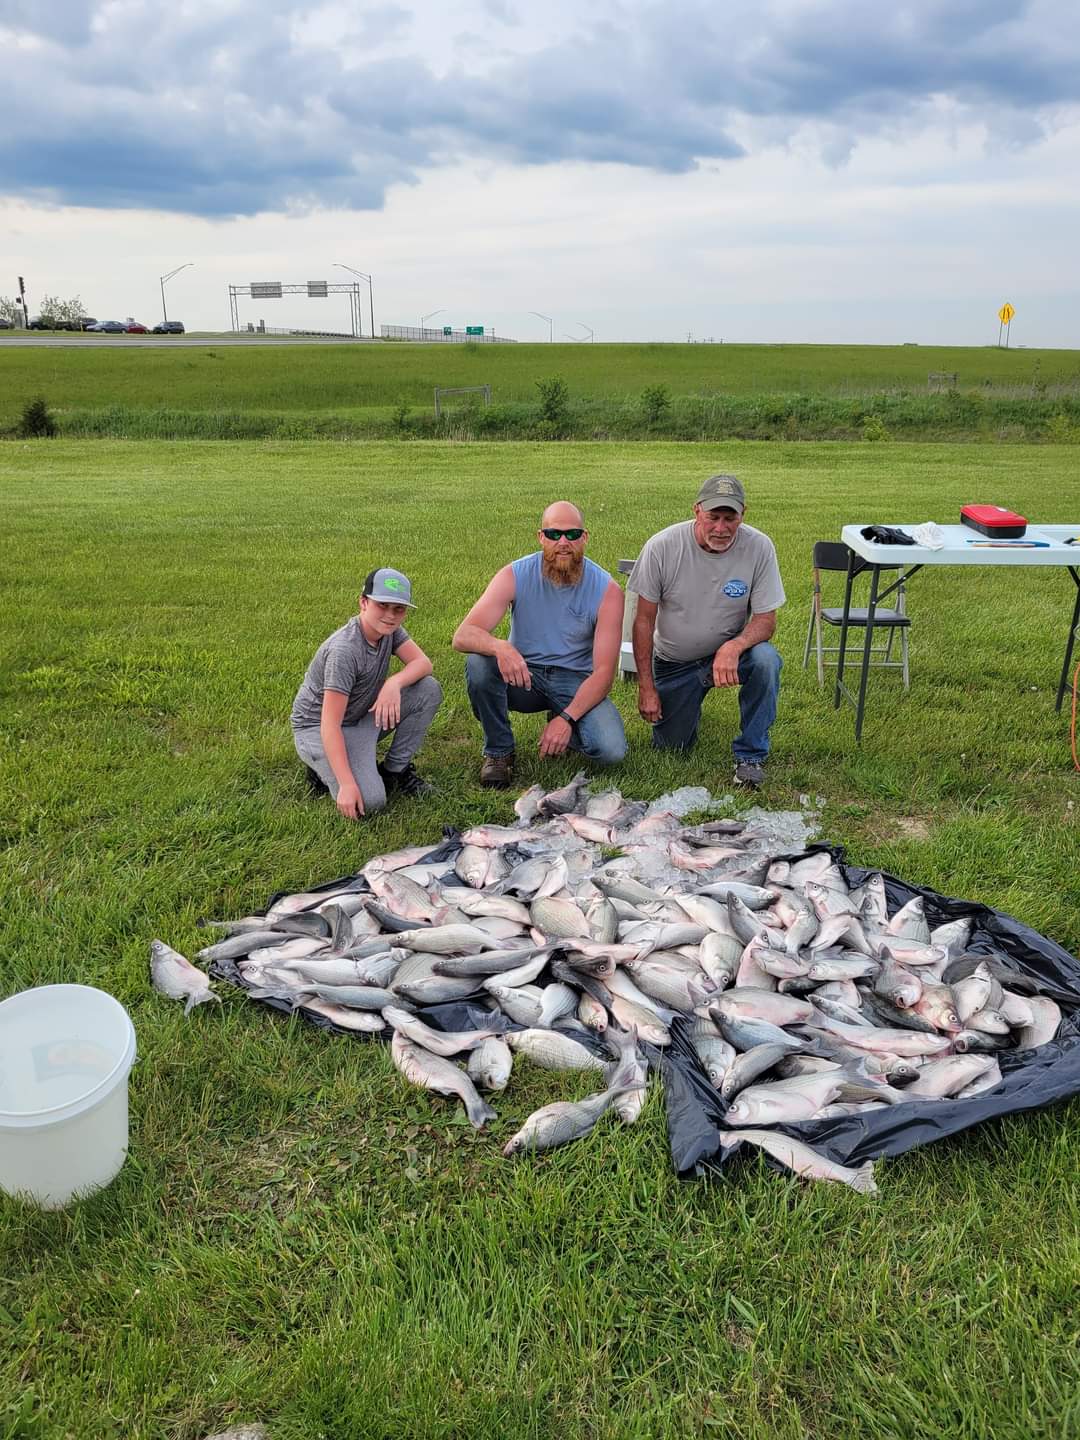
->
<box><xmin>626</xmin><ymin>520</ymin><xmax>785</xmax><ymax>660</ymax></box>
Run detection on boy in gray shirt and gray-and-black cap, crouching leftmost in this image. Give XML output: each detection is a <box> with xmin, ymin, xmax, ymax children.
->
<box><xmin>289</xmin><ymin>567</ymin><xmax>442</xmax><ymax>819</ymax></box>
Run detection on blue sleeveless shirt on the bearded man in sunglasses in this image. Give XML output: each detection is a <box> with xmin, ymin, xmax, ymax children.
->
<box><xmin>510</xmin><ymin>550</ymin><xmax>611</xmax><ymax>675</ymax></box>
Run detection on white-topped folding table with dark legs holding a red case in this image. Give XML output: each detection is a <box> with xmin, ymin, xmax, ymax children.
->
<box><xmin>832</xmin><ymin>523</ymin><xmax>1080</xmax><ymax>743</ymax></box>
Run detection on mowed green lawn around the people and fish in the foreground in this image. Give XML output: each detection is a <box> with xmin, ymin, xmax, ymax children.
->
<box><xmin>0</xmin><ymin>440</ymin><xmax>1080</xmax><ymax>1440</ymax></box>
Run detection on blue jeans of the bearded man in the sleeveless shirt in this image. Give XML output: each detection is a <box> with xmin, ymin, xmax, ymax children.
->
<box><xmin>465</xmin><ymin>655</ymin><xmax>626</xmax><ymax>765</ymax></box>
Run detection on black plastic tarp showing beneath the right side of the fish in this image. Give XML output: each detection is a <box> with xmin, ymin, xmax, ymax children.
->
<box><xmin>661</xmin><ymin>847</ymin><xmax>1080</xmax><ymax>1178</ymax></box>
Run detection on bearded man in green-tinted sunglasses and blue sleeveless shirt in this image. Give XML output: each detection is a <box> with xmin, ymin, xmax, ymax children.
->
<box><xmin>454</xmin><ymin>500</ymin><xmax>626</xmax><ymax>789</ymax></box>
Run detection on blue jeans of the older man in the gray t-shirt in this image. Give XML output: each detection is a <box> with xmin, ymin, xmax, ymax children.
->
<box><xmin>652</xmin><ymin>641</ymin><xmax>783</xmax><ymax>763</ymax></box>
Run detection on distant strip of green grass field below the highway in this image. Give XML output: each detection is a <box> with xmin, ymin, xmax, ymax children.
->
<box><xmin>0</xmin><ymin>337</ymin><xmax>1080</xmax><ymax>425</ymax></box>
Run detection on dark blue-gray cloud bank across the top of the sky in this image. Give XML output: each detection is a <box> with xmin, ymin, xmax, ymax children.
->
<box><xmin>0</xmin><ymin>0</ymin><xmax>1080</xmax><ymax>216</ymax></box>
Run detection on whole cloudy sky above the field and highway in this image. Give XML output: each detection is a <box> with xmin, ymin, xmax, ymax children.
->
<box><xmin>0</xmin><ymin>0</ymin><xmax>1080</xmax><ymax>347</ymax></box>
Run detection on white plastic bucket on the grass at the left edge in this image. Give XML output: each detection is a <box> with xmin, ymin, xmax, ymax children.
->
<box><xmin>0</xmin><ymin>985</ymin><xmax>135</xmax><ymax>1210</ymax></box>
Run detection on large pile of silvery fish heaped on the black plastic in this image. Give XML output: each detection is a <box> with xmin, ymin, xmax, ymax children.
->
<box><xmin>151</xmin><ymin>773</ymin><xmax>1061</xmax><ymax>1191</ymax></box>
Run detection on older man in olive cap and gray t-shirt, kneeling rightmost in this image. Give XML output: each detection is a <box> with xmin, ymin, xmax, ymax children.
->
<box><xmin>626</xmin><ymin>475</ymin><xmax>785</xmax><ymax>788</ymax></box>
